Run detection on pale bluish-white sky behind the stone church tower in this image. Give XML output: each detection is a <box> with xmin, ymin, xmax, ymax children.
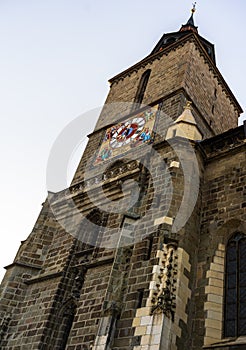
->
<box><xmin>0</xmin><ymin>0</ymin><xmax>246</xmax><ymax>278</ymax></box>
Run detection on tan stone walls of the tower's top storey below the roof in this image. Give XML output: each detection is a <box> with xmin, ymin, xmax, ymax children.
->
<box><xmin>93</xmin><ymin>41</ymin><xmax>239</xmax><ymax>136</ymax></box>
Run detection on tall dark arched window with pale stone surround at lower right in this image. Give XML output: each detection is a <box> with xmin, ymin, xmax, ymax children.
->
<box><xmin>224</xmin><ymin>233</ymin><xmax>246</xmax><ymax>337</ymax></box>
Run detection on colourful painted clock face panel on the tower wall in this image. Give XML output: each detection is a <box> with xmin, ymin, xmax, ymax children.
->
<box><xmin>94</xmin><ymin>105</ymin><xmax>159</xmax><ymax>164</ymax></box>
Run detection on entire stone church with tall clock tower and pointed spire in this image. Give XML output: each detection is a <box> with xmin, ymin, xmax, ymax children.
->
<box><xmin>0</xmin><ymin>8</ymin><xmax>246</xmax><ymax>350</ymax></box>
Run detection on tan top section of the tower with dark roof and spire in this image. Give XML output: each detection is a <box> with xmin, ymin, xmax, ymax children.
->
<box><xmin>92</xmin><ymin>3</ymin><xmax>242</xmax><ymax>137</ymax></box>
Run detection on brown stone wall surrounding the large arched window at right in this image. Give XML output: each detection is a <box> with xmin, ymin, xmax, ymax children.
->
<box><xmin>192</xmin><ymin>127</ymin><xmax>246</xmax><ymax>350</ymax></box>
